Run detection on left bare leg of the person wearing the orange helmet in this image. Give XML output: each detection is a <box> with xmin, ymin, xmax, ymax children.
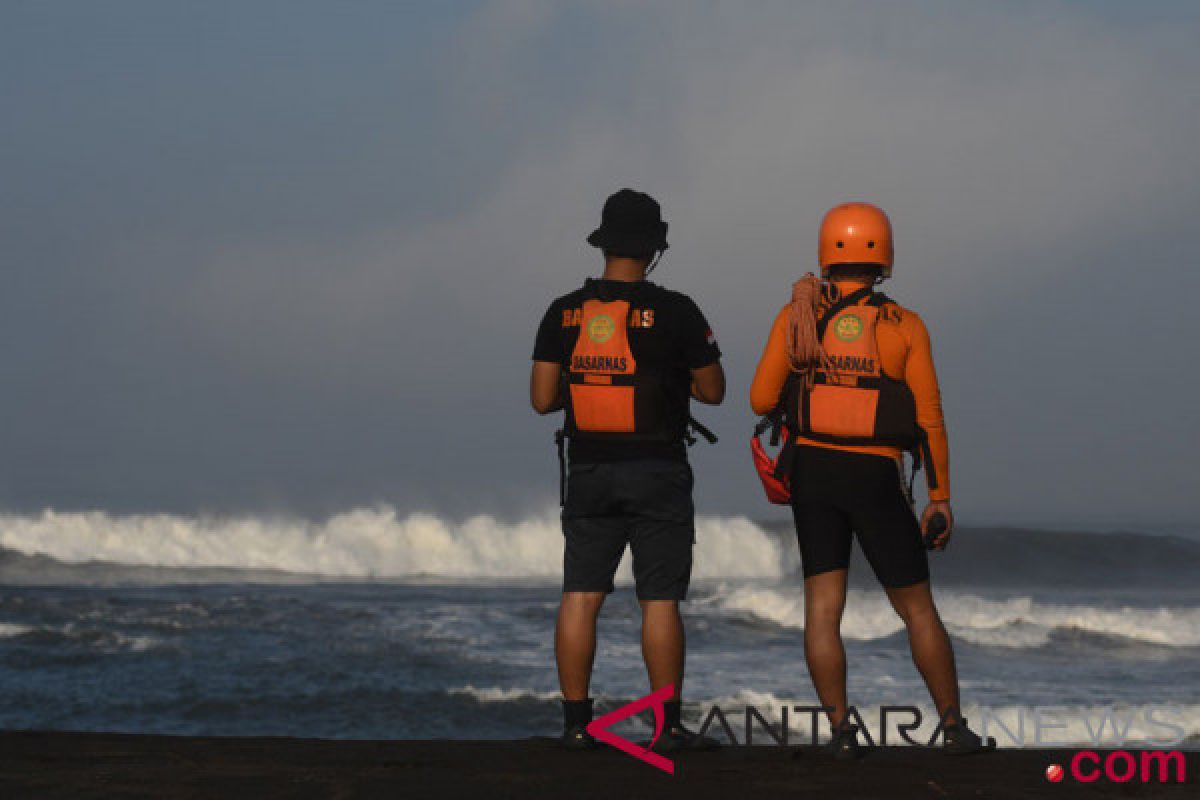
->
<box><xmin>804</xmin><ymin>570</ymin><xmax>846</xmax><ymax>727</ymax></box>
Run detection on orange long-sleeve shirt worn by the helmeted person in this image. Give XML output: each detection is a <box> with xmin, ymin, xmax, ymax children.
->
<box><xmin>750</xmin><ymin>284</ymin><xmax>950</xmax><ymax>500</ymax></box>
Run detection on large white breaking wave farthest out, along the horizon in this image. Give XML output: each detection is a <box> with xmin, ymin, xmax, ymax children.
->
<box><xmin>0</xmin><ymin>507</ymin><xmax>794</xmax><ymax>582</ymax></box>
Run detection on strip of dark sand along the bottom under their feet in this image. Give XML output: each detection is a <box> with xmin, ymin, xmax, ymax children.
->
<box><xmin>0</xmin><ymin>732</ymin><xmax>1200</xmax><ymax>800</ymax></box>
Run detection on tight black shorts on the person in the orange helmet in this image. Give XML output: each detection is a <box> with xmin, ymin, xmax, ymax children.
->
<box><xmin>792</xmin><ymin>446</ymin><xmax>929</xmax><ymax>589</ymax></box>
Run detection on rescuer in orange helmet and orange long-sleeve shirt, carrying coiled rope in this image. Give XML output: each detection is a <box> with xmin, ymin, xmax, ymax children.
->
<box><xmin>750</xmin><ymin>203</ymin><xmax>994</xmax><ymax>758</ymax></box>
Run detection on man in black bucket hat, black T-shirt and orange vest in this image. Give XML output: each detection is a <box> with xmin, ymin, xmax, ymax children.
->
<box><xmin>529</xmin><ymin>190</ymin><xmax>725</xmax><ymax>750</ymax></box>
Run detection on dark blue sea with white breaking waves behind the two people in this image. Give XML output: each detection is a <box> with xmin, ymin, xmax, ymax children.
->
<box><xmin>0</xmin><ymin>509</ymin><xmax>1200</xmax><ymax>747</ymax></box>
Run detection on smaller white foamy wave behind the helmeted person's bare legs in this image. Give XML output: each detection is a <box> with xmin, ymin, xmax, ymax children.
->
<box><xmin>697</xmin><ymin>585</ymin><xmax>1200</xmax><ymax>648</ymax></box>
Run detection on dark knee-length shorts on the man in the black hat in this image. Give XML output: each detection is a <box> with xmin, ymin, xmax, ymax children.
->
<box><xmin>563</xmin><ymin>459</ymin><xmax>696</xmax><ymax>600</ymax></box>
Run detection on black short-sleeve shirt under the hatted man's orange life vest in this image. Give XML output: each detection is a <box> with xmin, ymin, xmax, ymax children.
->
<box><xmin>533</xmin><ymin>279</ymin><xmax>721</xmax><ymax>463</ymax></box>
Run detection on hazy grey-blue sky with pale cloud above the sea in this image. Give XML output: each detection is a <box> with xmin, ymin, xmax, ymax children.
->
<box><xmin>0</xmin><ymin>0</ymin><xmax>1200</xmax><ymax>527</ymax></box>
